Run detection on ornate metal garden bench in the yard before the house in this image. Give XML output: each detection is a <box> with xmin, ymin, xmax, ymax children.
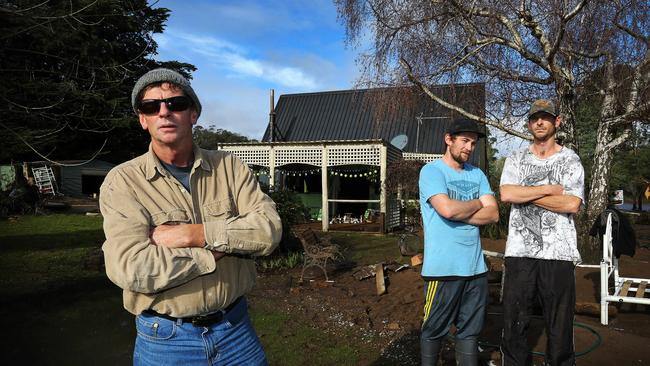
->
<box><xmin>292</xmin><ymin>227</ymin><xmax>343</xmax><ymax>282</ymax></box>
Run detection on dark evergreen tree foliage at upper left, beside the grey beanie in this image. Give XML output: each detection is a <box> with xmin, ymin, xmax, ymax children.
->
<box><xmin>0</xmin><ymin>0</ymin><xmax>195</xmax><ymax>161</ymax></box>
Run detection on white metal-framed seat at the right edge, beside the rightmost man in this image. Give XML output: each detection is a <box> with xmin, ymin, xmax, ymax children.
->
<box><xmin>600</xmin><ymin>213</ymin><xmax>650</xmax><ymax>325</ymax></box>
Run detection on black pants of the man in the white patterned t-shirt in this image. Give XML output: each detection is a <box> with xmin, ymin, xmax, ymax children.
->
<box><xmin>501</xmin><ymin>257</ymin><xmax>576</xmax><ymax>366</ymax></box>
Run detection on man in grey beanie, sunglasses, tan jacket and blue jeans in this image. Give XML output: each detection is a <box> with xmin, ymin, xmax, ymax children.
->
<box><xmin>100</xmin><ymin>69</ymin><xmax>282</xmax><ymax>365</ymax></box>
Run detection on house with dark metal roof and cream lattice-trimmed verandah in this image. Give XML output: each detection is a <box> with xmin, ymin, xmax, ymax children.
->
<box><xmin>219</xmin><ymin>84</ymin><xmax>480</xmax><ymax>231</ymax></box>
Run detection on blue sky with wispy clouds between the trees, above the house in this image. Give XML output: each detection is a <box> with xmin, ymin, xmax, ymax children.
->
<box><xmin>154</xmin><ymin>0</ymin><xmax>358</xmax><ymax>139</ymax></box>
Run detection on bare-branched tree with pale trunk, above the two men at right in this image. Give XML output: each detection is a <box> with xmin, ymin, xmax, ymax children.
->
<box><xmin>335</xmin><ymin>0</ymin><xmax>650</xmax><ymax>258</ymax></box>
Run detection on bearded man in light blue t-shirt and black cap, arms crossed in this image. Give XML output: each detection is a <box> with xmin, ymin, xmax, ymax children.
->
<box><xmin>419</xmin><ymin>119</ymin><xmax>499</xmax><ymax>365</ymax></box>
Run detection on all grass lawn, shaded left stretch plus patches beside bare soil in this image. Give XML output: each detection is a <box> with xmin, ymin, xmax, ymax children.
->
<box><xmin>0</xmin><ymin>214</ymin><xmax>404</xmax><ymax>366</ymax></box>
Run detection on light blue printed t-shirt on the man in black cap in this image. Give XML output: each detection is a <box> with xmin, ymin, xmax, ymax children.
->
<box><xmin>419</xmin><ymin>160</ymin><xmax>493</xmax><ymax>277</ymax></box>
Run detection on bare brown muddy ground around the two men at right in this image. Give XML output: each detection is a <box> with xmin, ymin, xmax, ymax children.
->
<box><xmin>250</xmin><ymin>226</ymin><xmax>650</xmax><ymax>366</ymax></box>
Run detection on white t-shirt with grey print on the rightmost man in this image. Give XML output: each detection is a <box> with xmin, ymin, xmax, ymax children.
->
<box><xmin>500</xmin><ymin>147</ymin><xmax>584</xmax><ymax>262</ymax></box>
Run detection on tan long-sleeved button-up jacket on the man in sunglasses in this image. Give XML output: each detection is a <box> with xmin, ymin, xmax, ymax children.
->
<box><xmin>99</xmin><ymin>147</ymin><xmax>282</xmax><ymax>317</ymax></box>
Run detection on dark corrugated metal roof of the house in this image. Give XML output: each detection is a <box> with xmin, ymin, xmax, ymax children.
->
<box><xmin>262</xmin><ymin>84</ymin><xmax>485</xmax><ymax>166</ymax></box>
